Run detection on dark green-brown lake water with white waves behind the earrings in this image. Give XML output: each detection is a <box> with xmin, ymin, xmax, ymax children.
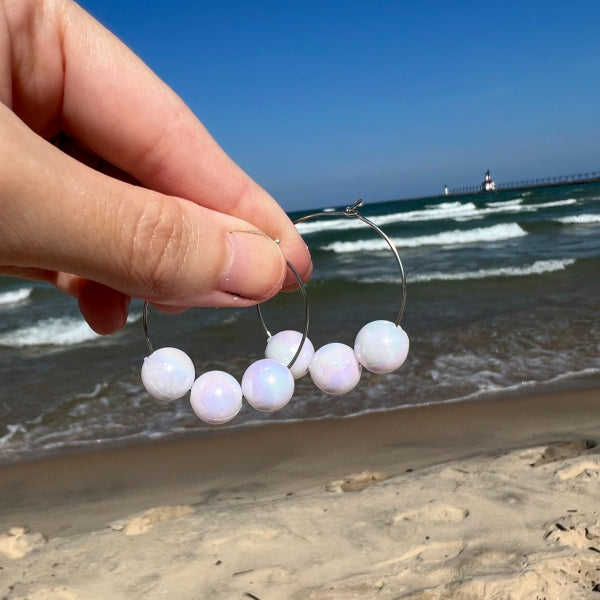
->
<box><xmin>0</xmin><ymin>184</ymin><xmax>600</xmax><ymax>462</ymax></box>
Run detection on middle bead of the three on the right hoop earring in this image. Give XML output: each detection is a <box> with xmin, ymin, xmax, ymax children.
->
<box><xmin>309</xmin><ymin>342</ymin><xmax>362</xmax><ymax>395</ymax></box>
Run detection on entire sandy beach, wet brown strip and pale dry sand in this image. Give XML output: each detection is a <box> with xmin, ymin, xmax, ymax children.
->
<box><xmin>0</xmin><ymin>390</ymin><xmax>600</xmax><ymax>600</ymax></box>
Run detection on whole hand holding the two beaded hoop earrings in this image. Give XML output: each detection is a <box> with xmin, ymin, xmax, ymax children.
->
<box><xmin>0</xmin><ymin>0</ymin><xmax>312</xmax><ymax>334</ymax></box>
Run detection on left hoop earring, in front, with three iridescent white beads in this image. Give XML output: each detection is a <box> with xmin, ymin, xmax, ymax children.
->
<box><xmin>141</xmin><ymin>261</ymin><xmax>309</xmax><ymax>425</ymax></box>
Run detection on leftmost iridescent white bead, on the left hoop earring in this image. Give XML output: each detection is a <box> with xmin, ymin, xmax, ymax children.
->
<box><xmin>142</xmin><ymin>348</ymin><xmax>196</xmax><ymax>400</ymax></box>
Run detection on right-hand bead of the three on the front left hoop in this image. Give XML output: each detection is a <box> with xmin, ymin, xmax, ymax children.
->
<box><xmin>242</xmin><ymin>358</ymin><xmax>294</xmax><ymax>412</ymax></box>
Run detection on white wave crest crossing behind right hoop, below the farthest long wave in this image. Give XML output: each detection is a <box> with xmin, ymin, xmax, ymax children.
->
<box><xmin>321</xmin><ymin>223</ymin><xmax>527</xmax><ymax>253</ymax></box>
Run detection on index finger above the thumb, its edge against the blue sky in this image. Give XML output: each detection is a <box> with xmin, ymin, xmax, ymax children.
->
<box><xmin>53</xmin><ymin>4</ymin><xmax>311</xmax><ymax>284</ymax></box>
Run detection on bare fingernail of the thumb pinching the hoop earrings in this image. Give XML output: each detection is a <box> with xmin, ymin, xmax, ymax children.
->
<box><xmin>221</xmin><ymin>231</ymin><xmax>285</xmax><ymax>301</ymax></box>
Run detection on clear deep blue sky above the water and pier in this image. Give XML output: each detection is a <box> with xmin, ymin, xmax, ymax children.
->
<box><xmin>81</xmin><ymin>0</ymin><xmax>600</xmax><ymax>210</ymax></box>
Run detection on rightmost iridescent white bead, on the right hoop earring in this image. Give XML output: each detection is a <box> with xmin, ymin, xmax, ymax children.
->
<box><xmin>354</xmin><ymin>321</ymin><xmax>409</xmax><ymax>373</ymax></box>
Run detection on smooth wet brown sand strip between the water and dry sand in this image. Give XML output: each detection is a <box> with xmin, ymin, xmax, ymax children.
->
<box><xmin>0</xmin><ymin>389</ymin><xmax>600</xmax><ymax>536</ymax></box>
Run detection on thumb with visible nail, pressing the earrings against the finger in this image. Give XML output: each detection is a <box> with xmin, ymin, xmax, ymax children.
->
<box><xmin>0</xmin><ymin>107</ymin><xmax>285</xmax><ymax>306</ymax></box>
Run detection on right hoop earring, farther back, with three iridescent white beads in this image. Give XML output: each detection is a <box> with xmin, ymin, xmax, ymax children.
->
<box><xmin>257</xmin><ymin>200</ymin><xmax>409</xmax><ymax>395</ymax></box>
